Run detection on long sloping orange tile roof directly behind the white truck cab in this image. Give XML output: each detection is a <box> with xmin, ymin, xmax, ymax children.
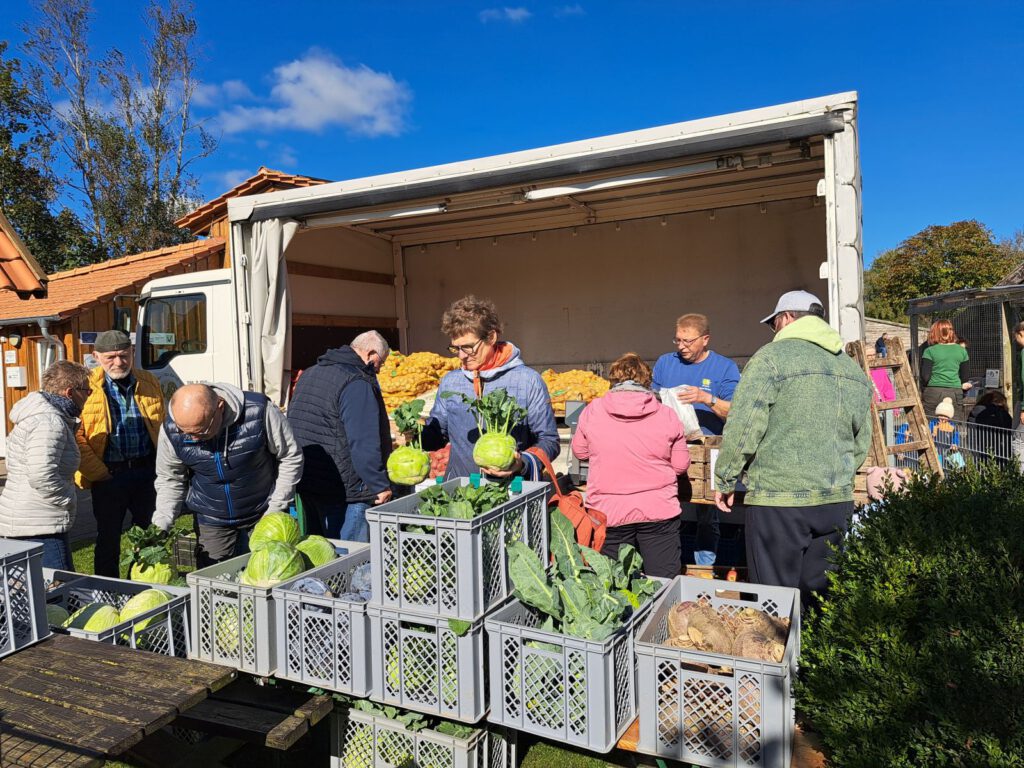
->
<box><xmin>0</xmin><ymin>238</ymin><xmax>224</xmax><ymax>319</ymax></box>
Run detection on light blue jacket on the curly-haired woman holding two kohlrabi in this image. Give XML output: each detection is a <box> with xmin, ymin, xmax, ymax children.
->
<box><xmin>421</xmin><ymin>342</ymin><xmax>559</xmax><ymax>479</ymax></box>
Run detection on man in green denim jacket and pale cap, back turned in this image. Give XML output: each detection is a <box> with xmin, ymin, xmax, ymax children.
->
<box><xmin>715</xmin><ymin>291</ymin><xmax>871</xmax><ymax>605</ymax></box>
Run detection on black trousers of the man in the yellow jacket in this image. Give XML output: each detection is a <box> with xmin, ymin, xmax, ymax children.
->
<box><xmin>92</xmin><ymin>467</ymin><xmax>157</xmax><ymax>579</ymax></box>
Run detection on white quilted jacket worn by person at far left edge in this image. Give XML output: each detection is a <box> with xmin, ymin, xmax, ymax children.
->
<box><xmin>0</xmin><ymin>392</ymin><xmax>79</xmax><ymax>537</ymax></box>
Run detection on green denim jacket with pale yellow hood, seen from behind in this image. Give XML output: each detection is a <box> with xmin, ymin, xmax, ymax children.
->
<box><xmin>715</xmin><ymin>315</ymin><xmax>872</xmax><ymax>507</ymax></box>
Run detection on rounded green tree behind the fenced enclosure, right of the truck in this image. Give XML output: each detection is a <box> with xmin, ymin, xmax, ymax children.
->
<box><xmin>864</xmin><ymin>220</ymin><xmax>1020</xmax><ymax>321</ymax></box>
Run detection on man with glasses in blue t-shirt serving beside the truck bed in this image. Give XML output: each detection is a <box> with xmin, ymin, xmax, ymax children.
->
<box><xmin>651</xmin><ymin>313</ymin><xmax>739</xmax><ymax>565</ymax></box>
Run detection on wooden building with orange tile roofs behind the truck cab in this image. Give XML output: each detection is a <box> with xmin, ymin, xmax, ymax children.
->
<box><xmin>0</xmin><ymin>168</ymin><xmax>323</xmax><ymax>448</ymax></box>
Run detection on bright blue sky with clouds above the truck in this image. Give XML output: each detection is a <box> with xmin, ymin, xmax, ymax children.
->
<box><xmin>0</xmin><ymin>0</ymin><xmax>1024</xmax><ymax>260</ymax></box>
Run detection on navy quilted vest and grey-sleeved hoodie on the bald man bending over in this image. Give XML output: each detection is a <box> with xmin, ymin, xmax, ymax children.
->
<box><xmin>153</xmin><ymin>383</ymin><xmax>302</xmax><ymax>530</ymax></box>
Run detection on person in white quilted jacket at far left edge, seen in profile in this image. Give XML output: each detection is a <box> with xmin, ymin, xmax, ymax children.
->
<box><xmin>0</xmin><ymin>360</ymin><xmax>91</xmax><ymax>569</ymax></box>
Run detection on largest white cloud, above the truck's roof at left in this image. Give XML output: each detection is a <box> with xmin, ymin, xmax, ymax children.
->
<box><xmin>217</xmin><ymin>50</ymin><xmax>412</xmax><ymax>136</ymax></box>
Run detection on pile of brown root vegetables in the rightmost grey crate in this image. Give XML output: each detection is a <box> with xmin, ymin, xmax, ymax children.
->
<box><xmin>666</xmin><ymin>600</ymin><xmax>790</xmax><ymax>664</ymax></box>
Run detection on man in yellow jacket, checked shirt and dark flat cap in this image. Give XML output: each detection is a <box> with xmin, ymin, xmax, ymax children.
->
<box><xmin>78</xmin><ymin>331</ymin><xmax>164</xmax><ymax>578</ymax></box>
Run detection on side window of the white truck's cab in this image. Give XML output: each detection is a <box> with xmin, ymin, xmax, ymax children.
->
<box><xmin>142</xmin><ymin>294</ymin><xmax>207</xmax><ymax>368</ymax></box>
